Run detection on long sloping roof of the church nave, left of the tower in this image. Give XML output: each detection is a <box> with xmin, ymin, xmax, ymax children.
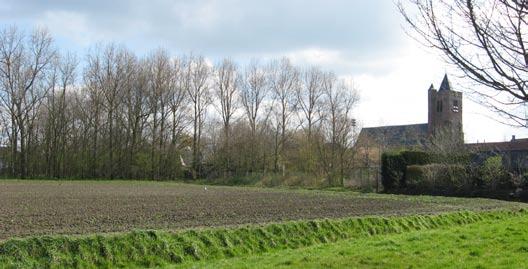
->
<box><xmin>358</xmin><ymin>123</ymin><xmax>427</xmax><ymax>147</ymax></box>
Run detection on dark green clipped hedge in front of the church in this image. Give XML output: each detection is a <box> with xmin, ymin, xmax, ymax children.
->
<box><xmin>382</xmin><ymin>151</ymin><xmax>525</xmax><ymax>200</ymax></box>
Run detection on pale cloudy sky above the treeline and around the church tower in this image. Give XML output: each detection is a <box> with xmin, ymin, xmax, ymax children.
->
<box><xmin>0</xmin><ymin>0</ymin><xmax>528</xmax><ymax>142</ymax></box>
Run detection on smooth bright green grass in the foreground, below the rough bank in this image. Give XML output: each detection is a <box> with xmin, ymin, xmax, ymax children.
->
<box><xmin>185</xmin><ymin>210</ymin><xmax>528</xmax><ymax>269</ymax></box>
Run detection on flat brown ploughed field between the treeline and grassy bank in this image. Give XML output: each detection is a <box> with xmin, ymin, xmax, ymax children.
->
<box><xmin>0</xmin><ymin>180</ymin><xmax>524</xmax><ymax>239</ymax></box>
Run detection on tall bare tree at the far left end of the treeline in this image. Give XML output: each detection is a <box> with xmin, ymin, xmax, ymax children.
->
<box><xmin>0</xmin><ymin>27</ymin><xmax>55</xmax><ymax>177</ymax></box>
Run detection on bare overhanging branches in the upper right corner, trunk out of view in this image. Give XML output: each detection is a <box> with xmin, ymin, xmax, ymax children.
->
<box><xmin>398</xmin><ymin>0</ymin><xmax>528</xmax><ymax>127</ymax></box>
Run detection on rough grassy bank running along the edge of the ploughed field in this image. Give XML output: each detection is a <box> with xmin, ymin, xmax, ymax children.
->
<box><xmin>0</xmin><ymin>210</ymin><xmax>528</xmax><ymax>268</ymax></box>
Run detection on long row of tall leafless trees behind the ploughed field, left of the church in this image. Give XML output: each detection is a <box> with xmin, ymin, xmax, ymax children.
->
<box><xmin>0</xmin><ymin>27</ymin><xmax>358</xmax><ymax>185</ymax></box>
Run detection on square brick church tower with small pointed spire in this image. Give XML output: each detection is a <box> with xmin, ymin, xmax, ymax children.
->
<box><xmin>427</xmin><ymin>74</ymin><xmax>464</xmax><ymax>143</ymax></box>
